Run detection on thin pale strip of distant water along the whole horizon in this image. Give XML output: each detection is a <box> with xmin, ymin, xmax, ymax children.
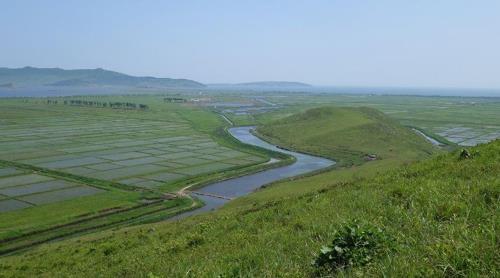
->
<box><xmin>0</xmin><ymin>86</ymin><xmax>500</xmax><ymax>97</ymax></box>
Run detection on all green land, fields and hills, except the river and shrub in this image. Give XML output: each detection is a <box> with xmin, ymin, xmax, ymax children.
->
<box><xmin>0</xmin><ymin>92</ymin><xmax>500</xmax><ymax>277</ymax></box>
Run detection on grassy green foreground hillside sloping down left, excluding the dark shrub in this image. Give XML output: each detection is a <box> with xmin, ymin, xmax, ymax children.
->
<box><xmin>0</xmin><ymin>114</ymin><xmax>500</xmax><ymax>277</ymax></box>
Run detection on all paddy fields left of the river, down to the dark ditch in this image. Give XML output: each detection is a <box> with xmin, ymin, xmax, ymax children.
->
<box><xmin>0</xmin><ymin>96</ymin><xmax>269</xmax><ymax>249</ymax></box>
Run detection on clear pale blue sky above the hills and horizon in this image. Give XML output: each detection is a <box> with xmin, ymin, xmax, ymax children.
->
<box><xmin>0</xmin><ymin>0</ymin><xmax>500</xmax><ymax>88</ymax></box>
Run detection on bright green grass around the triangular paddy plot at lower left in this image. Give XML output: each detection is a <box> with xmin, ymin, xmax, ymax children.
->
<box><xmin>0</xmin><ymin>161</ymin><xmax>150</xmax><ymax>240</ymax></box>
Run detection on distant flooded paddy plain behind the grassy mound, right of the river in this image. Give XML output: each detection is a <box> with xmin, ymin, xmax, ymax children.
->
<box><xmin>221</xmin><ymin>92</ymin><xmax>500</xmax><ymax>146</ymax></box>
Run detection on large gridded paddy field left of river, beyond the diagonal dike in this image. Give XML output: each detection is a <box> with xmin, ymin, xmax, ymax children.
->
<box><xmin>0</xmin><ymin>98</ymin><xmax>265</xmax><ymax>191</ymax></box>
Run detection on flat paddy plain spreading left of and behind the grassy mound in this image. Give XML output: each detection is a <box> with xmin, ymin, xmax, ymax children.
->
<box><xmin>0</xmin><ymin>92</ymin><xmax>500</xmax><ymax>235</ymax></box>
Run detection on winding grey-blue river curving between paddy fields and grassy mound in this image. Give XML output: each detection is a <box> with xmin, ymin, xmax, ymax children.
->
<box><xmin>172</xmin><ymin>126</ymin><xmax>335</xmax><ymax>219</ymax></box>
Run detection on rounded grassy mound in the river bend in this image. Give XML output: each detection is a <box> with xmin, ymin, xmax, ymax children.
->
<box><xmin>258</xmin><ymin>107</ymin><xmax>435</xmax><ymax>166</ymax></box>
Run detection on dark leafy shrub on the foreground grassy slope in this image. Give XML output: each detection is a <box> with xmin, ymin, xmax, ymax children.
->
<box><xmin>314</xmin><ymin>220</ymin><xmax>388</xmax><ymax>270</ymax></box>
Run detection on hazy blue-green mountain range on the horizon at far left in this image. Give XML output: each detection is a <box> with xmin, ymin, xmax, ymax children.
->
<box><xmin>0</xmin><ymin>67</ymin><xmax>205</xmax><ymax>88</ymax></box>
